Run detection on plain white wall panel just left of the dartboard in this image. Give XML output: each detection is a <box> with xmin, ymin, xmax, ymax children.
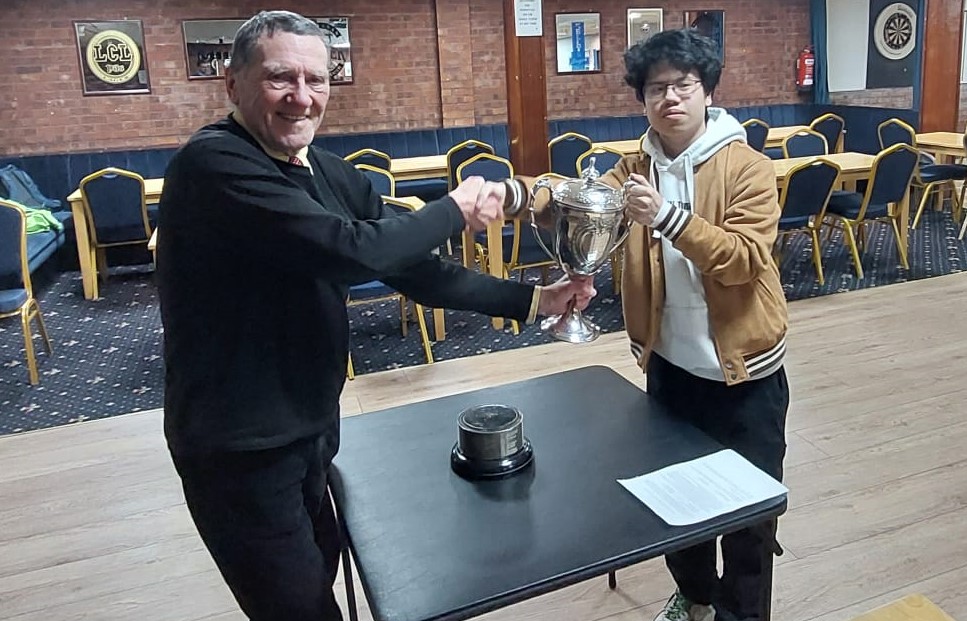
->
<box><xmin>826</xmin><ymin>0</ymin><xmax>872</xmax><ymax>93</ymax></box>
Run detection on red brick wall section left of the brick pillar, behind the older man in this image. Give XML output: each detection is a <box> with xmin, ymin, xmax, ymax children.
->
<box><xmin>0</xmin><ymin>0</ymin><xmax>441</xmax><ymax>155</ymax></box>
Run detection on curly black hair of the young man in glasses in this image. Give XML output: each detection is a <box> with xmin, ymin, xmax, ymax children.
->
<box><xmin>625</xmin><ymin>28</ymin><xmax>722</xmax><ymax>102</ymax></box>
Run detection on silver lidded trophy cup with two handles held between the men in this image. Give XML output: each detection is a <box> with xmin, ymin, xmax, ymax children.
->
<box><xmin>530</xmin><ymin>157</ymin><xmax>630</xmax><ymax>343</ymax></box>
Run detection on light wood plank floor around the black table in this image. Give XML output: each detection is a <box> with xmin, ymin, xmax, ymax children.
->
<box><xmin>0</xmin><ymin>274</ymin><xmax>967</xmax><ymax>621</ymax></box>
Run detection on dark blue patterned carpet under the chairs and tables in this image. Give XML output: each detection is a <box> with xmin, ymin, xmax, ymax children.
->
<box><xmin>0</xmin><ymin>206</ymin><xmax>967</xmax><ymax>434</ymax></box>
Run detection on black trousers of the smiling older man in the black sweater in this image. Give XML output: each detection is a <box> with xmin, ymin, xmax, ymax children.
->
<box><xmin>174</xmin><ymin>438</ymin><xmax>342</xmax><ymax>621</ymax></box>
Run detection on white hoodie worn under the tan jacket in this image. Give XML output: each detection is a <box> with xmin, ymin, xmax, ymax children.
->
<box><xmin>642</xmin><ymin>108</ymin><xmax>746</xmax><ymax>381</ymax></box>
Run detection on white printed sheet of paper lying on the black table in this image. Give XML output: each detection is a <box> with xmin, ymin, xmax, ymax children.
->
<box><xmin>618</xmin><ymin>449</ymin><xmax>789</xmax><ymax>526</ymax></box>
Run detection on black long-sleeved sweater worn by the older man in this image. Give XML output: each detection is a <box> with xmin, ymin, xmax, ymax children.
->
<box><xmin>157</xmin><ymin>118</ymin><xmax>533</xmax><ymax>458</ymax></box>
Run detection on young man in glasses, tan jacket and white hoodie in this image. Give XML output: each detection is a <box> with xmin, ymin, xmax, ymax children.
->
<box><xmin>507</xmin><ymin>29</ymin><xmax>789</xmax><ymax>621</ymax></box>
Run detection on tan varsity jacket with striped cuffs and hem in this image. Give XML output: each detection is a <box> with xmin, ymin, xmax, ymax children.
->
<box><xmin>517</xmin><ymin>142</ymin><xmax>788</xmax><ymax>385</ymax></box>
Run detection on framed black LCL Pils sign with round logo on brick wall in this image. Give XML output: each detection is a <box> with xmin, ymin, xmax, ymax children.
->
<box><xmin>74</xmin><ymin>19</ymin><xmax>151</xmax><ymax>95</ymax></box>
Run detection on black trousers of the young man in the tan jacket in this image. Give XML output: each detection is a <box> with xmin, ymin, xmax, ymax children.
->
<box><xmin>648</xmin><ymin>354</ymin><xmax>789</xmax><ymax>621</ymax></box>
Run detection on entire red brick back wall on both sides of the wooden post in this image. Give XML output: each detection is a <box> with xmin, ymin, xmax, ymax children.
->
<box><xmin>0</xmin><ymin>0</ymin><xmax>928</xmax><ymax>155</ymax></box>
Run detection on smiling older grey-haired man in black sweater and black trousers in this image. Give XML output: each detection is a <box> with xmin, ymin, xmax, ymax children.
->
<box><xmin>158</xmin><ymin>11</ymin><xmax>594</xmax><ymax>621</ymax></box>
